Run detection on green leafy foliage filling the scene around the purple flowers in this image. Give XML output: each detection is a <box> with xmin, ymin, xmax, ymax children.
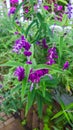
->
<box><xmin>0</xmin><ymin>0</ymin><xmax>73</xmax><ymax>130</ymax></box>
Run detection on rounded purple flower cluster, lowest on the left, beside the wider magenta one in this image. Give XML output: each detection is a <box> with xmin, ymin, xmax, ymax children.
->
<box><xmin>14</xmin><ymin>66</ymin><xmax>25</xmax><ymax>81</ymax></box>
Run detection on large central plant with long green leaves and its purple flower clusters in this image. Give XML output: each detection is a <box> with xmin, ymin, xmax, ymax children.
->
<box><xmin>0</xmin><ymin>1</ymin><xmax>73</xmax><ymax>128</ymax></box>
